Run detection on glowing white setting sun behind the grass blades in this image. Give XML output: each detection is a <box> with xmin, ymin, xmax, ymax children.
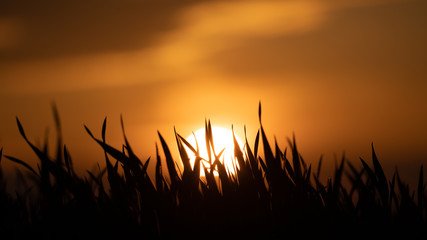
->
<box><xmin>186</xmin><ymin>126</ymin><xmax>243</xmax><ymax>176</ymax></box>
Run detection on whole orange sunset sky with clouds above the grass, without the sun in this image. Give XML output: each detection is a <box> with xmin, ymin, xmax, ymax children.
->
<box><xmin>0</xmin><ymin>0</ymin><xmax>427</xmax><ymax>184</ymax></box>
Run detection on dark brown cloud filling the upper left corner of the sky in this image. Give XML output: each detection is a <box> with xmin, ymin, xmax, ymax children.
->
<box><xmin>0</xmin><ymin>0</ymin><xmax>214</xmax><ymax>61</ymax></box>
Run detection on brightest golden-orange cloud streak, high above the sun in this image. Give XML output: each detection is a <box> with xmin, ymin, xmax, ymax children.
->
<box><xmin>155</xmin><ymin>1</ymin><xmax>324</xmax><ymax>71</ymax></box>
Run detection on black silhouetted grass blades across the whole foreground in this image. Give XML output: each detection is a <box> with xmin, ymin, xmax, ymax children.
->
<box><xmin>0</xmin><ymin>104</ymin><xmax>427</xmax><ymax>239</ymax></box>
